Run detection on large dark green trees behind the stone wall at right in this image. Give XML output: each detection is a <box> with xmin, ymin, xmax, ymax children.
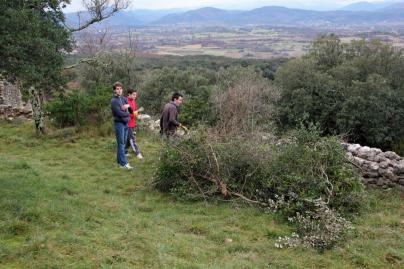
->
<box><xmin>276</xmin><ymin>35</ymin><xmax>404</xmax><ymax>149</ymax></box>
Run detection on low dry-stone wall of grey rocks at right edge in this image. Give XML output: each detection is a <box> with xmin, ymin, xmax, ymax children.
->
<box><xmin>343</xmin><ymin>143</ymin><xmax>404</xmax><ymax>191</ymax></box>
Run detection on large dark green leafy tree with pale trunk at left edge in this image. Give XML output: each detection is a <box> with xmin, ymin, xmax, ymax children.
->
<box><xmin>0</xmin><ymin>0</ymin><xmax>128</xmax><ymax>134</ymax></box>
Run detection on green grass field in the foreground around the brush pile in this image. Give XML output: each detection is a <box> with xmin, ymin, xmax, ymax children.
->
<box><xmin>0</xmin><ymin>122</ymin><xmax>404</xmax><ymax>268</ymax></box>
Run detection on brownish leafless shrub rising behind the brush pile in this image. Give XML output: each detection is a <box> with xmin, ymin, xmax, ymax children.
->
<box><xmin>213</xmin><ymin>67</ymin><xmax>279</xmax><ymax>136</ymax></box>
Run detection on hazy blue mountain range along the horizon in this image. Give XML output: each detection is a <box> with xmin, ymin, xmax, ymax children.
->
<box><xmin>66</xmin><ymin>1</ymin><xmax>404</xmax><ymax>27</ymax></box>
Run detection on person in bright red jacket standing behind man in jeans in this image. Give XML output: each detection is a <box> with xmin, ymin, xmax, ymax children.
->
<box><xmin>125</xmin><ymin>89</ymin><xmax>143</xmax><ymax>159</ymax></box>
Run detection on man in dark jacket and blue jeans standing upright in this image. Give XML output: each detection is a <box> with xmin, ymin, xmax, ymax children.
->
<box><xmin>111</xmin><ymin>82</ymin><xmax>132</xmax><ymax>170</ymax></box>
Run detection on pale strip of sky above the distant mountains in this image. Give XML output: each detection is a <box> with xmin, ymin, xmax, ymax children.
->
<box><xmin>65</xmin><ymin>0</ymin><xmax>390</xmax><ymax>12</ymax></box>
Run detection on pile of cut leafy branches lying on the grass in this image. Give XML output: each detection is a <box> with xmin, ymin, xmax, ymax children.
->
<box><xmin>155</xmin><ymin>126</ymin><xmax>364</xmax><ymax>248</ymax></box>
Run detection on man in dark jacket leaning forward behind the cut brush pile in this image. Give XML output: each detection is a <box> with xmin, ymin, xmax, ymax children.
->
<box><xmin>160</xmin><ymin>92</ymin><xmax>183</xmax><ymax>136</ymax></box>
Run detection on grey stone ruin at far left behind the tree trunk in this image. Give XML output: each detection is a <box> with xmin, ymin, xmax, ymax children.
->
<box><xmin>0</xmin><ymin>79</ymin><xmax>32</xmax><ymax>120</ymax></box>
